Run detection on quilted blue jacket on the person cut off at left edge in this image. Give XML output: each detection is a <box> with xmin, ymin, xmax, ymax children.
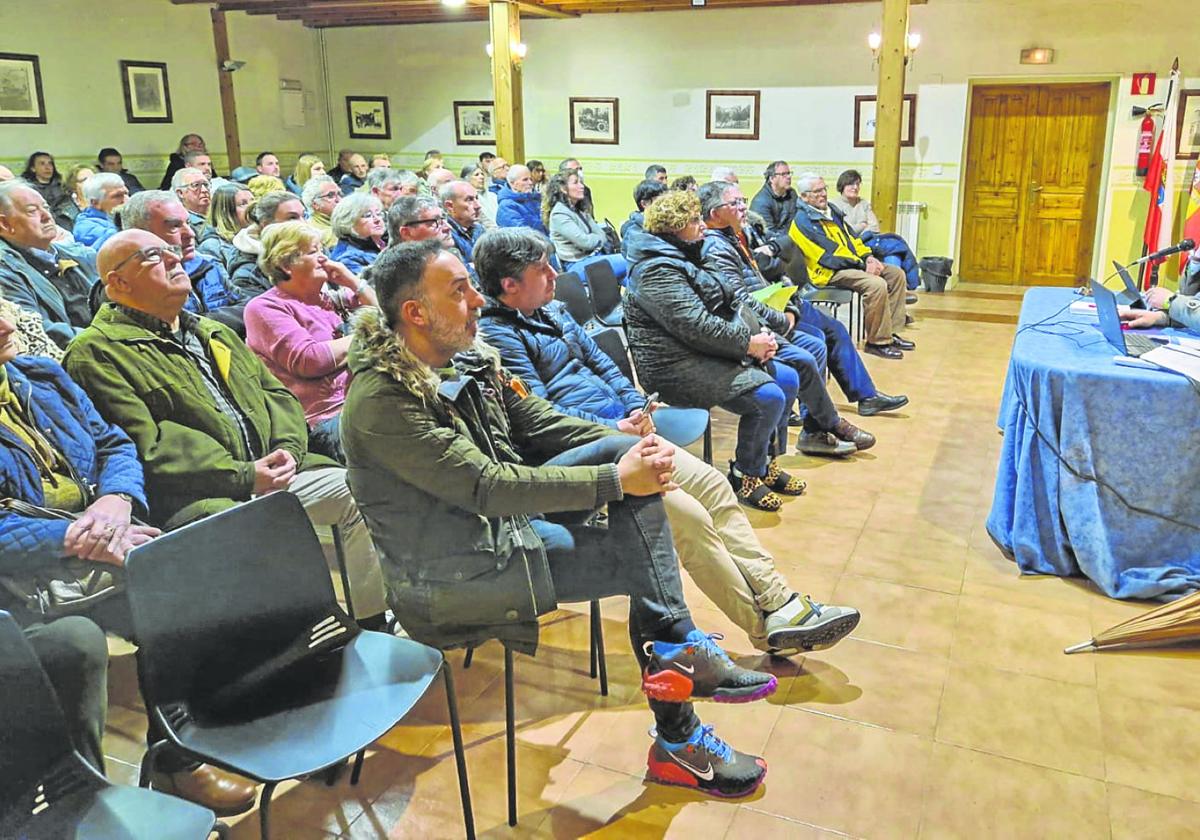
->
<box><xmin>0</xmin><ymin>356</ymin><xmax>146</xmax><ymax>575</ymax></box>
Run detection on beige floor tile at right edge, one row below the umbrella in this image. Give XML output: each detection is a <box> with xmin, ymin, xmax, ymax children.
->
<box><xmin>1100</xmin><ymin>694</ymin><xmax>1200</xmax><ymax>802</ymax></box>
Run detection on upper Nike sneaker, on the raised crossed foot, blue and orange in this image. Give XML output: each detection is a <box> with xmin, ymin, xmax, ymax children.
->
<box><xmin>642</xmin><ymin>630</ymin><xmax>779</xmax><ymax>703</ymax></box>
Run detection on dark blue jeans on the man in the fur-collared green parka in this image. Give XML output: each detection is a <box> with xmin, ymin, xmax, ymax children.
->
<box><xmin>530</xmin><ymin>436</ymin><xmax>700</xmax><ymax>742</ymax></box>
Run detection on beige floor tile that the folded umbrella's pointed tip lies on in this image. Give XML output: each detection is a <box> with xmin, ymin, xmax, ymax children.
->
<box><xmin>950</xmin><ymin>595</ymin><xmax>1096</xmax><ymax>685</ymax></box>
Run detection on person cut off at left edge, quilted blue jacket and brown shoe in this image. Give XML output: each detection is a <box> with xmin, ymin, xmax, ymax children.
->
<box><xmin>0</xmin><ymin>307</ymin><xmax>254</xmax><ymax>815</ymax></box>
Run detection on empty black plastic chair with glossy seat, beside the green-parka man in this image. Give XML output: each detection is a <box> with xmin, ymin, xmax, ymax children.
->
<box><xmin>126</xmin><ymin>492</ymin><xmax>474</xmax><ymax>840</ymax></box>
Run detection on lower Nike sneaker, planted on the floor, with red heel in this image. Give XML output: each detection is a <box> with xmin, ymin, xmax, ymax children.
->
<box><xmin>646</xmin><ymin>726</ymin><xmax>767</xmax><ymax>799</ymax></box>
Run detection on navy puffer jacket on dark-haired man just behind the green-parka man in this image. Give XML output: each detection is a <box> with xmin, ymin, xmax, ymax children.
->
<box><xmin>479</xmin><ymin>300</ymin><xmax>646</xmax><ymax>428</ymax></box>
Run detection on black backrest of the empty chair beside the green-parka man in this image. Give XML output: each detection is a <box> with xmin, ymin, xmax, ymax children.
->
<box><xmin>125</xmin><ymin>492</ymin><xmax>350</xmax><ymax>708</ymax></box>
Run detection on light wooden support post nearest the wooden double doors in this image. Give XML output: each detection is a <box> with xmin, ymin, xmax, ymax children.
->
<box><xmin>871</xmin><ymin>0</ymin><xmax>908</xmax><ymax>230</ymax></box>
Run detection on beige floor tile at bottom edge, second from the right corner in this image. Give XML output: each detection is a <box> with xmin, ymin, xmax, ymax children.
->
<box><xmin>920</xmin><ymin>744</ymin><xmax>1109</xmax><ymax>840</ymax></box>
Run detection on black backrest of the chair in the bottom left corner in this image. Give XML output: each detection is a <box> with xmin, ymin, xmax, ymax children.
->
<box><xmin>0</xmin><ymin>611</ymin><xmax>73</xmax><ymax>814</ymax></box>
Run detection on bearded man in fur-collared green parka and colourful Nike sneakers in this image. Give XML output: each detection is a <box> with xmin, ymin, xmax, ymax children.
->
<box><xmin>342</xmin><ymin>242</ymin><xmax>776</xmax><ymax>797</ymax></box>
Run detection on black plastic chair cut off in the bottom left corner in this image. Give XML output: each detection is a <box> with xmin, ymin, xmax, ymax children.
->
<box><xmin>0</xmin><ymin>611</ymin><xmax>228</xmax><ymax>840</ymax></box>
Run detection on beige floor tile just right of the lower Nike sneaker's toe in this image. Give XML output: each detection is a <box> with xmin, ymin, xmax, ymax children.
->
<box><xmin>754</xmin><ymin>709</ymin><xmax>932</xmax><ymax>838</ymax></box>
